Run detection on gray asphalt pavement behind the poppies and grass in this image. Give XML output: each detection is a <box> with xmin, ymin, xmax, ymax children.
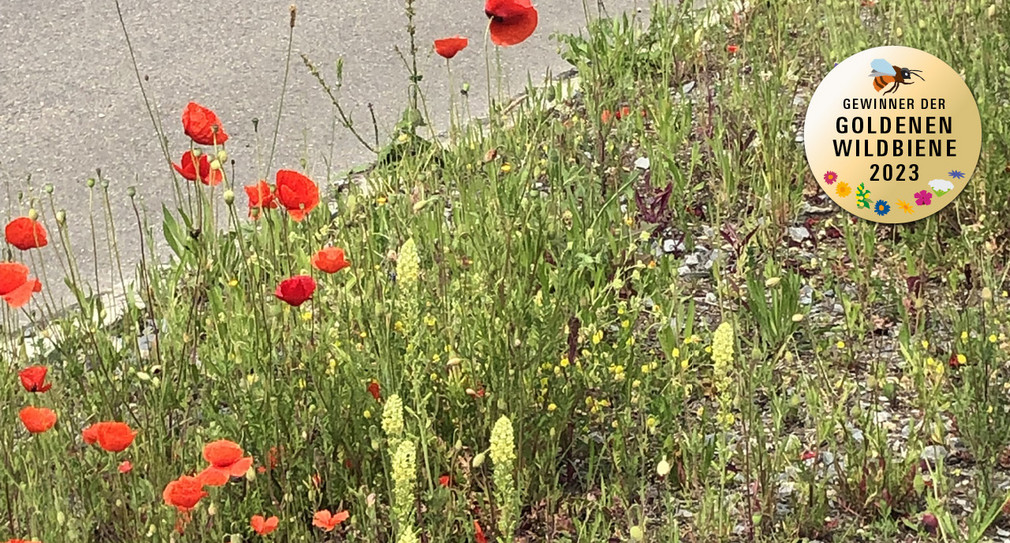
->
<box><xmin>0</xmin><ymin>0</ymin><xmax>647</xmax><ymax>306</ymax></box>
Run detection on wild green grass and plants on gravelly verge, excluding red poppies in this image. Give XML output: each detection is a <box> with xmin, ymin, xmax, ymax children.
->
<box><xmin>0</xmin><ymin>0</ymin><xmax>1010</xmax><ymax>543</ymax></box>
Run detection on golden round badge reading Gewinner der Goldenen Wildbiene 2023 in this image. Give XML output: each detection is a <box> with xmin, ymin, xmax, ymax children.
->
<box><xmin>803</xmin><ymin>45</ymin><xmax>982</xmax><ymax>223</ymax></box>
